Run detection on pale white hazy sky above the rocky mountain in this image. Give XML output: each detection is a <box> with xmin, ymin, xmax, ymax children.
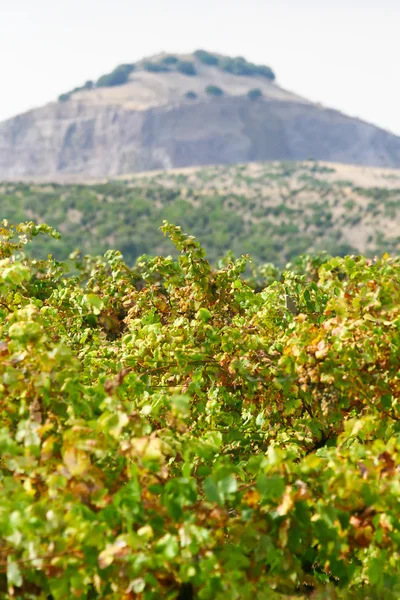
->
<box><xmin>0</xmin><ymin>0</ymin><xmax>400</xmax><ymax>135</ymax></box>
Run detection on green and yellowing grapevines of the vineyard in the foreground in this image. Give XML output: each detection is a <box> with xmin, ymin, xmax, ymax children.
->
<box><xmin>0</xmin><ymin>221</ymin><xmax>400</xmax><ymax>600</ymax></box>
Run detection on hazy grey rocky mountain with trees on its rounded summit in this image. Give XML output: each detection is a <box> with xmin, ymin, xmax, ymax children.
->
<box><xmin>0</xmin><ymin>51</ymin><xmax>400</xmax><ymax>181</ymax></box>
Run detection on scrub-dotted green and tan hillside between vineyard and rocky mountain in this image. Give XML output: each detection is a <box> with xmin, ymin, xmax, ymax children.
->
<box><xmin>0</xmin><ymin>161</ymin><xmax>400</xmax><ymax>267</ymax></box>
